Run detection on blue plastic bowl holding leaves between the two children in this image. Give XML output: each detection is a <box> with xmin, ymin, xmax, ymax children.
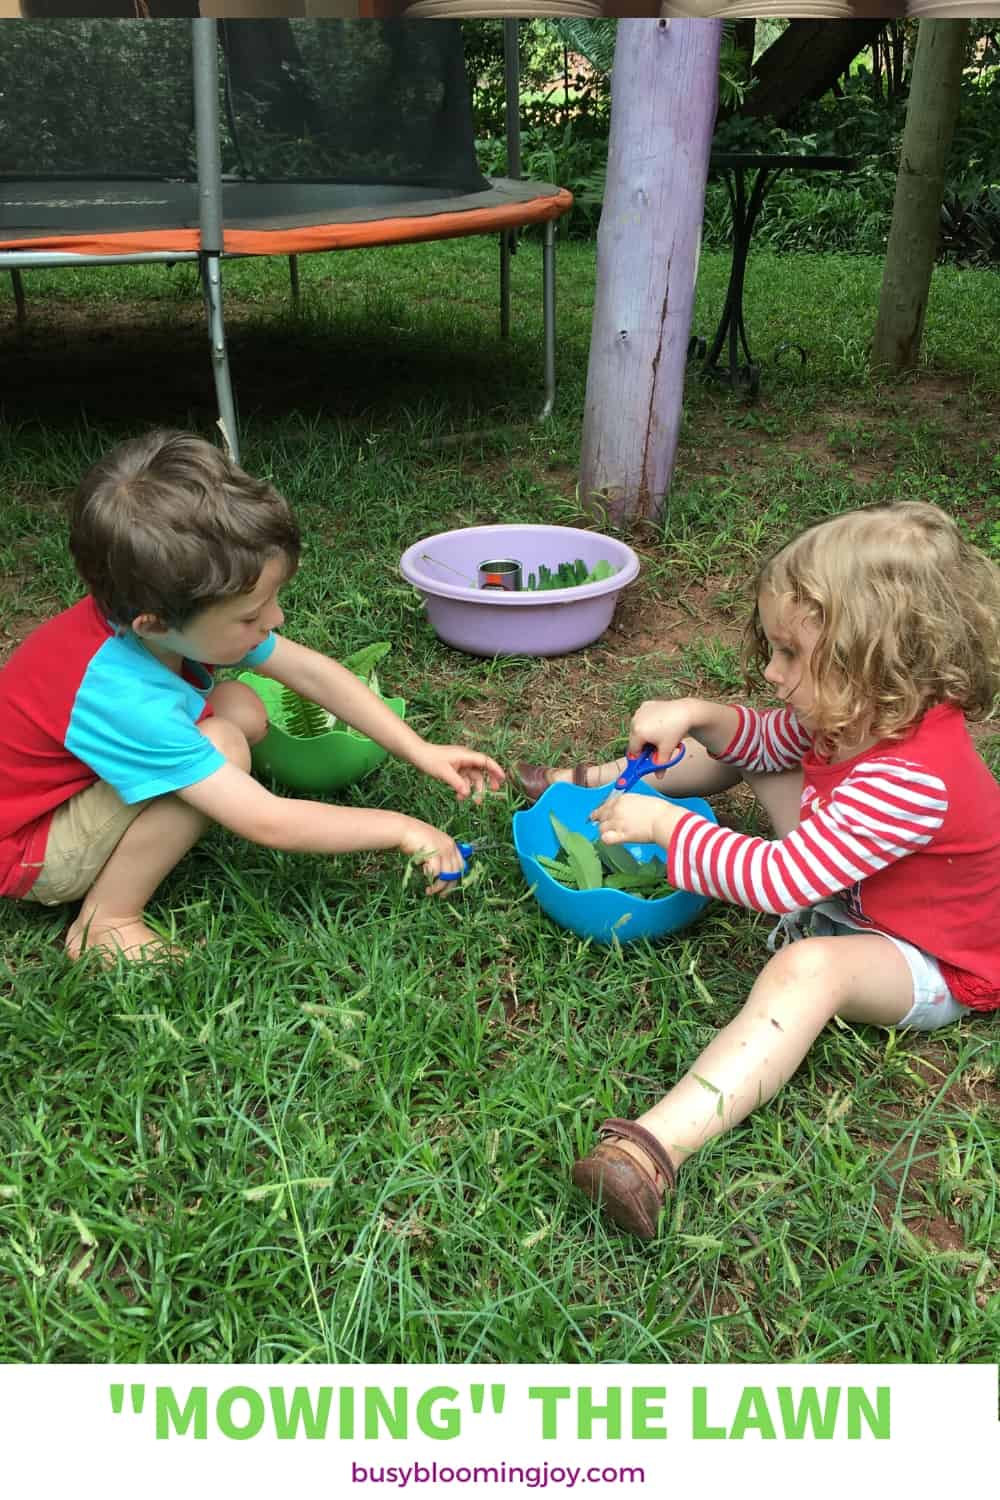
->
<box><xmin>514</xmin><ymin>782</ymin><xmax>717</xmax><ymax>944</ymax></box>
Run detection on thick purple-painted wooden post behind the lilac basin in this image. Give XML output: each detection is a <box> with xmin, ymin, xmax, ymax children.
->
<box><xmin>580</xmin><ymin>20</ymin><xmax>723</xmax><ymax>525</ymax></box>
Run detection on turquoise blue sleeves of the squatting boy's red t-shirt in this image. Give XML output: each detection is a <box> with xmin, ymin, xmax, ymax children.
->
<box><xmin>66</xmin><ymin>633</ymin><xmax>276</xmax><ymax>803</ymax></box>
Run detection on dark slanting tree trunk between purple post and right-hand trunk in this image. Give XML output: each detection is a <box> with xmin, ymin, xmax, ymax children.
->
<box><xmin>735</xmin><ymin>21</ymin><xmax>885</xmax><ymax>122</ymax></box>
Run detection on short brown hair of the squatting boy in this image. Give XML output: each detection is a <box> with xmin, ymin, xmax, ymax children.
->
<box><xmin>69</xmin><ymin>429</ymin><xmax>301</xmax><ymax>630</ymax></box>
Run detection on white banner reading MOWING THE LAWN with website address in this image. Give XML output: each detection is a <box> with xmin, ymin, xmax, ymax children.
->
<box><xmin>0</xmin><ymin>1365</ymin><xmax>1000</xmax><ymax>1500</ymax></box>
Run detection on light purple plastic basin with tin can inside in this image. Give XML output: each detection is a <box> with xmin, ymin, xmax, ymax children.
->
<box><xmin>399</xmin><ymin>527</ymin><xmax>639</xmax><ymax>656</ymax></box>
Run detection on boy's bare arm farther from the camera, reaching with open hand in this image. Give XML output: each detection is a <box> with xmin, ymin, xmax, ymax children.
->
<box><xmin>255</xmin><ymin>636</ymin><xmax>504</xmax><ymax>798</ymax></box>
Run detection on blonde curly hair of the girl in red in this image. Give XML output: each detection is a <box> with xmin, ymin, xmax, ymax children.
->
<box><xmin>744</xmin><ymin>500</ymin><xmax>1000</xmax><ymax>749</ymax></box>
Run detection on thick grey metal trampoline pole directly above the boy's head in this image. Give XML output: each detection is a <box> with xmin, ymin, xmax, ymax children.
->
<box><xmin>190</xmin><ymin>18</ymin><xmax>240</xmax><ymax>464</ymax></box>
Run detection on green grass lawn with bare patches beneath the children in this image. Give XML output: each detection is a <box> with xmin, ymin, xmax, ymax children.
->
<box><xmin>0</xmin><ymin>231</ymin><xmax>1000</xmax><ymax>1362</ymax></box>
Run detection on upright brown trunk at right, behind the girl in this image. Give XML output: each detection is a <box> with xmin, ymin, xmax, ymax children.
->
<box><xmin>871</xmin><ymin>20</ymin><xmax>969</xmax><ymax>374</ymax></box>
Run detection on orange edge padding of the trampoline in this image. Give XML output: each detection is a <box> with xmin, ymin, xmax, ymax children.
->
<box><xmin>0</xmin><ymin>179</ymin><xmax>573</xmax><ymax>260</ymax></box>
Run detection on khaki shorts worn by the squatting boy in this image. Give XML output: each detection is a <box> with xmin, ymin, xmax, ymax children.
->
<box><xmin>24</xmin><ymin>782</ymin><xmax>150</xmax><ymax>906</ymax></box>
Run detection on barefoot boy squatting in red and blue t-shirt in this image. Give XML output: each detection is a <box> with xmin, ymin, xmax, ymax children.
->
<box><xmin>0</xmin><ymin>431</ymin><xmax>504</xmax><ymax>959</ymax></box>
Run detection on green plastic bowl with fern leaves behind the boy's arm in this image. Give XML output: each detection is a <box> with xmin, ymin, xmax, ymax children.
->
<box><xmin>238</xmin><ymin>672</ymin><xmax>406</xmax><ymax>792</ymax></box>
